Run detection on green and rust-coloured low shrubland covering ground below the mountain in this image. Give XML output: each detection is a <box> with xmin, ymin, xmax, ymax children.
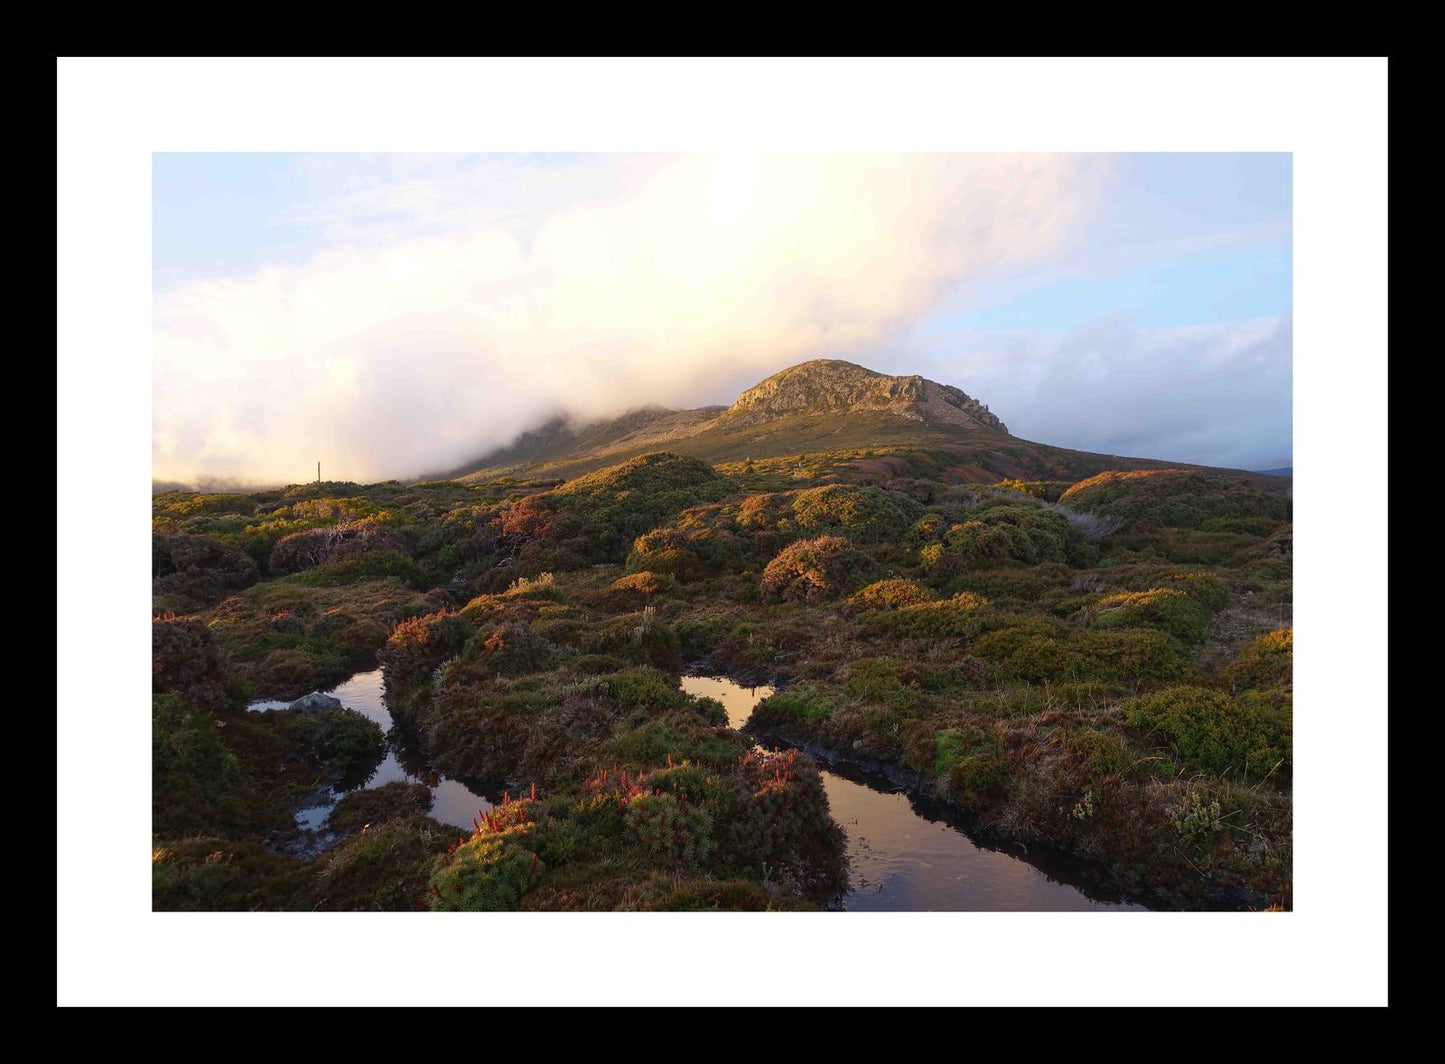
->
<box><xmin>153</xmin><ymin>450</ymin><xmax>1292</xmax><ymax>909</ymax></box>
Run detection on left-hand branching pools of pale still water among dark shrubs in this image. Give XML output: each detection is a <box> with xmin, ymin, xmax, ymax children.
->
<box><xmin>247</xmin><ymin>669</ymin><xmax>491</xmax><ymax>831</ymax></box>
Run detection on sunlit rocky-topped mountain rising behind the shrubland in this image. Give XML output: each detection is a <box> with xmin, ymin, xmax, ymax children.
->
<box><xmin>445</xmin><ymin>359</ymin><xmax>1283</xmax><ymax>483</ymax></box>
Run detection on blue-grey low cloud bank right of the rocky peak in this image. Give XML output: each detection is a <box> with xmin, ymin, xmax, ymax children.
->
<box><xmin>910</xmin><ymin>315</ymin><xmax>1293</xmax><ymax>468</ymax></box>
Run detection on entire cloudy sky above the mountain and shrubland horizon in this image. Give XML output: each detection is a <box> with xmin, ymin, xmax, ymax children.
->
<box><xmin>152</xmin><ymin>153</ymin><xmax>1292</xmax><ymax>484</ymax></box>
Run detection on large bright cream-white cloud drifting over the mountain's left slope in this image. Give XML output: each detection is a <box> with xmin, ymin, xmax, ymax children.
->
<box><xmin>153</xmin><ymin>155</ymin><xmax>1107</xmax><ymax>481</ymax></box>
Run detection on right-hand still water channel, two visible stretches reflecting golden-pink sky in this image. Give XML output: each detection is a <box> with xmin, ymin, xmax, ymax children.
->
<box><xmin>682</xmin><ymin>677</ymin><xmax>1143</xmax><ymax>911</ymax></box>
